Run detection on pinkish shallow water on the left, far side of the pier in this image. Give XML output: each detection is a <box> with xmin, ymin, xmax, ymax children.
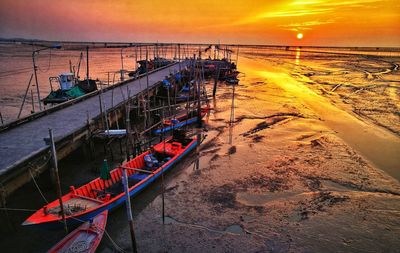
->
<box><xmin>0</xmin><ymin>43</ymin><xmax>192</xmax><ymax>122</ymax></box>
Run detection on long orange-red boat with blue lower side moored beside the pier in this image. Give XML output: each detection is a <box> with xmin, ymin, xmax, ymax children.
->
<box><xmin>22</xmin><ymin>134</ymin><xmax>197</xmax><ymax>229</ymax></box>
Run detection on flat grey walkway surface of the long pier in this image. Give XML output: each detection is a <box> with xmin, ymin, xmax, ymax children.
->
<box><xmin>0</xmin><ymin>62</ymin><xmax>185</xmax><ymax>192</ymax></box>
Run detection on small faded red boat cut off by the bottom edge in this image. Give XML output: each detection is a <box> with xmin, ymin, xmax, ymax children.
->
<box><xmin>47</xmin><ymin>210</ymin><xmax>108</xmax><ymax>253</ymax></box>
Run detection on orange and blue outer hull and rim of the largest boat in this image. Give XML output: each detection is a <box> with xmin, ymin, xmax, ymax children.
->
<box><xmin>22</xmin><ymin>138</ymin><xmax>197</xmax><ymax>229</ymax></box>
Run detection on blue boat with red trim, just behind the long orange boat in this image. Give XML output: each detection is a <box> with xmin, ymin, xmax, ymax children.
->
<box><xmin>152</xmin><ymin>105</ymin><xmax>210</xmax><ymax>134</ymax></box>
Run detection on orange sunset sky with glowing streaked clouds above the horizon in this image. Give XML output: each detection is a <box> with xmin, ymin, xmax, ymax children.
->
<box><xmin>0</xmin><ymin>0</ymin><xmax>400</xmax><ymax>47</ymax></box>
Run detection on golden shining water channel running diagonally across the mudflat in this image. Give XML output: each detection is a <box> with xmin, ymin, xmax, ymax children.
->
<box><xmin>239</xmin><ymin>56</ymin><xmax>400</xmax><ymax>180</ymax></box>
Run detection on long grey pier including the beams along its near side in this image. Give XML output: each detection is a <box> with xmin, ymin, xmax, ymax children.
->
<box><xmin>0</xmin><ymin>61</ymin><xmax>189</xmax><ymax>198</ymax></box>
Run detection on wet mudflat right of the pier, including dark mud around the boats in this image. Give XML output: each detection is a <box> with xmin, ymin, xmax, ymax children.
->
<box><xmin>0</xmin><ymin>51</ymin><xmax>400</xmax><ymax>252</ymax></box>
